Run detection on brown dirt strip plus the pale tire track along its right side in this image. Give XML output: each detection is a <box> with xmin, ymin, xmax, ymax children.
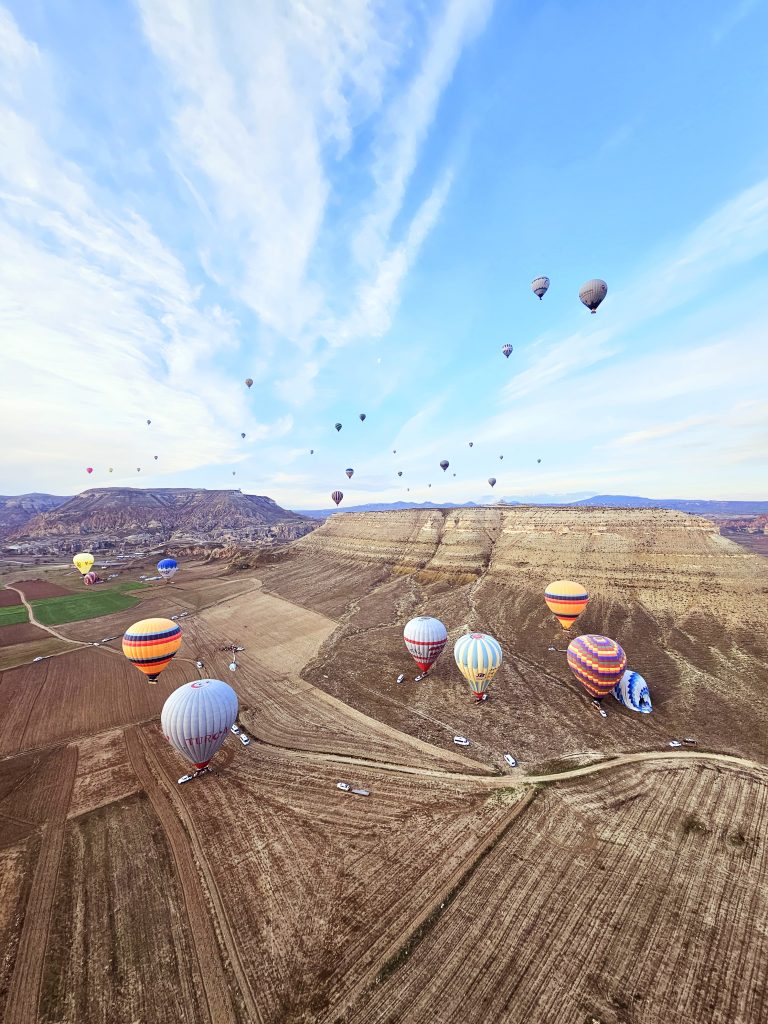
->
<box><xmin>125</xmin><ymin>727</ymin><xmax>262</xmax><ymax>1024</ymax></box>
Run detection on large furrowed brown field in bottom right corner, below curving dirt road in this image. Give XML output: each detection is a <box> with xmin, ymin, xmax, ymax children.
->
<box><xmin>344</xmin><ymin>767</ymin><xmax>768</xmax><ymax>1024</ymax></box>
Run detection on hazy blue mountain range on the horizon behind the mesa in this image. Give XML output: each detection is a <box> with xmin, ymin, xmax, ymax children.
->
<box><xmin>300</xmin><ymin>495</ymin><xmax>768</xmax><ymax>519</ymax></box>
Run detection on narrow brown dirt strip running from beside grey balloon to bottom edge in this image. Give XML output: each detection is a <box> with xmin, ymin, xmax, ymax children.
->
<box><xmin>123</xmin><ymin>725</ymin><xmax>233</xmax><ymax>1024</ymax></box>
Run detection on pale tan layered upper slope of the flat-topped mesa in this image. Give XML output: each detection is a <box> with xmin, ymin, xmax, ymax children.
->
<box><xmin>293</xmin><ymin>506</ymin><xmax>768</xmax><ymax>622</ymax></box>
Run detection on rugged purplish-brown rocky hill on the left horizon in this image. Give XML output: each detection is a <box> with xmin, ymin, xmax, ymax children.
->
<box><xmin>8</xmin><ymin>487</ymin><xmax>315</xmax><ymax>551</ymax></box>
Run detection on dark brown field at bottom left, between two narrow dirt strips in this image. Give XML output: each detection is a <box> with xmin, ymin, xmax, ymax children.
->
<box><xmin>37</xmin><ymin>794</ymin><xmax>211</xmax><ymax>1024</ymax></box>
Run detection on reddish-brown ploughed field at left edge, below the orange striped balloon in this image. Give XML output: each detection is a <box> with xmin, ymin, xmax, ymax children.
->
<box><xmin>0</xmin><ymin>648</ymin><xmax>197</xmax><ymax>756</ymax></box>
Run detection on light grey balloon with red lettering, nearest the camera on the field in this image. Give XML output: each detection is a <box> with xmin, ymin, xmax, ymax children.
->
<box><xmin>160</xmin><ymin>679</ymin><xmax>238</xmax><ymax>771</ymax></box>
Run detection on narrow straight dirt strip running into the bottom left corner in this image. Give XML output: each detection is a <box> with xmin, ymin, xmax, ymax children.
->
<box><xmin>5</xmin><ymin>743</ymin><xmax>78</xmax><ymax>1024</ymax></box>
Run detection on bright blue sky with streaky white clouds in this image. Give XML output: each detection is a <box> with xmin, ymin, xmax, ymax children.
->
<box><xmin>0</xmin><ymin>0</ymin><xmax>768</xmax><ymax>508</ymax></box>
